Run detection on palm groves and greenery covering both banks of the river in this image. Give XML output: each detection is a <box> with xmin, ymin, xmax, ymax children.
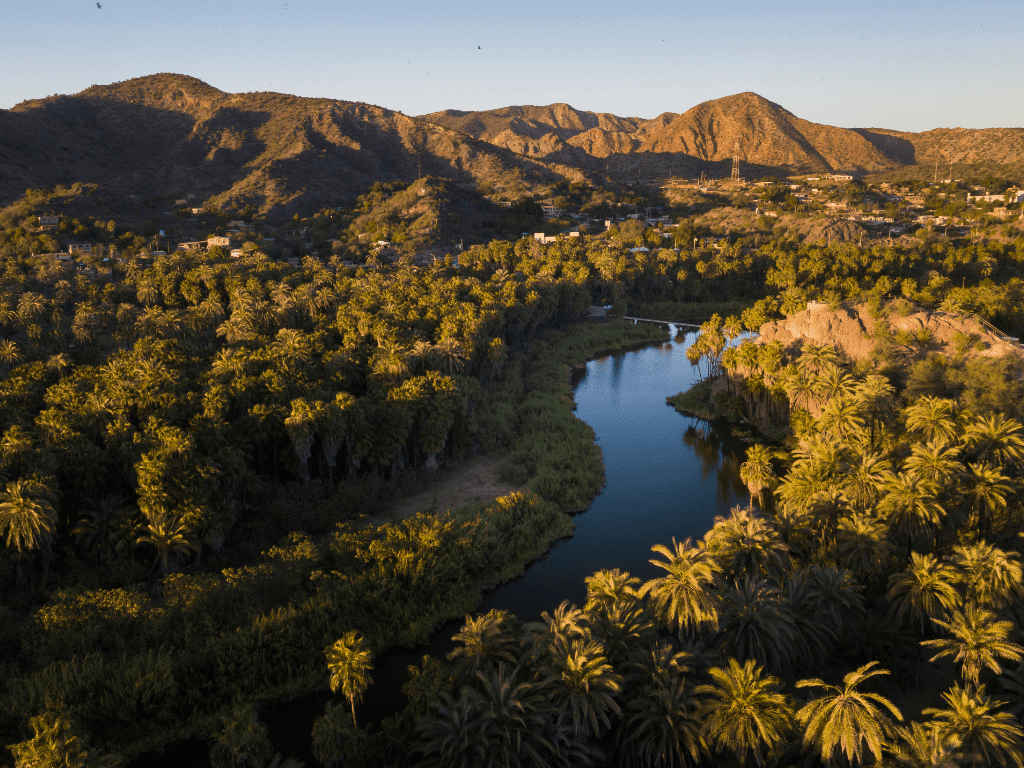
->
<box><xmin>0</xmin><ymin>189</ymin><xmax>1024</xmax><ymax>765</ymax></box>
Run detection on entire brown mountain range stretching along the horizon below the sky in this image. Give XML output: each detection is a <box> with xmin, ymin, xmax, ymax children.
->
<box><xmin>0</xmin><ymin>74</ymin><xmax>1024</xmax><ymax>214</ymax></box>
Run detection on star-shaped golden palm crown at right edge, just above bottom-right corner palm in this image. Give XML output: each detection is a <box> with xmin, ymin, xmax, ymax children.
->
<box><xmin>921</xmin><ymin>603</ymin><xmax>1024</xmax><ymax>685</ymax></box>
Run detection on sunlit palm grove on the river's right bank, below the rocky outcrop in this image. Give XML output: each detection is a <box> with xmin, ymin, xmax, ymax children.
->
<box><xmin>290</xmin><ymin>346</ymin><xmax>1024</xmax><ymax>766</ymax></box>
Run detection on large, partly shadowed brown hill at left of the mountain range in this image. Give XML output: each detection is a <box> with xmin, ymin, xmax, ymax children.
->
<box><xmin>0</xmin><ymin>75</ymin><xmax>561</xmax><ymax>214</ymax></box>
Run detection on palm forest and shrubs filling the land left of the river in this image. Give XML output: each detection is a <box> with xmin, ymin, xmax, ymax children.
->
<box><xmin>0</xmin><ymin>234</ymin><xmax>675</xmax><ymax>765</ymax></box>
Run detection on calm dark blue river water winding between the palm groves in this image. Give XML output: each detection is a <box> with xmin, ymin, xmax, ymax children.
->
<box><xmin>132</xmin><ymin>328</ymin><xmax>749</xmax><ymax>768</ymax></box>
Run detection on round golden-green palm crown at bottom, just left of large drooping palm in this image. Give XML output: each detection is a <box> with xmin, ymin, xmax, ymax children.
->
<box><xmin>696</xmin><ymin>658</ymin><xmax>794</xmax><ymax>766</ymax></box>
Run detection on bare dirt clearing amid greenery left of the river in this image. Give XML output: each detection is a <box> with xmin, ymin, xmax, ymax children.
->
<box><xmin>374</xmin><ymin>456</ymin><xmax>519</xmax><ymax>524</ymax></box>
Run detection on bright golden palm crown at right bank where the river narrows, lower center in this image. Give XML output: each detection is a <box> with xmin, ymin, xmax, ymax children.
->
<box><xmin>639</xmin><ymin>538</ymin><xmax>719</xmax><ymax>637</ymax></box>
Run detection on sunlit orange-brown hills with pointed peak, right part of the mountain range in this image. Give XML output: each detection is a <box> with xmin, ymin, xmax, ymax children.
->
<box><xmin>423</xmin><ymin>92</ymin><xmax>1024</xmax><ymax>175</ymax></box>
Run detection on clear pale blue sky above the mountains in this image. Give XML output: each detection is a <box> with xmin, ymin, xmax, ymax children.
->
<box><xmin>0</xmin><ymin>0</ymin><xmax>1024</xmax><ymax>131</ymax></box>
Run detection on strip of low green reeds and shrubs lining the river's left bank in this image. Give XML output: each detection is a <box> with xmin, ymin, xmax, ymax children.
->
<box><xmin>72</xmin><ymin>323</ymin><xmax>666</xmax><ymax>765</ymax></box>
